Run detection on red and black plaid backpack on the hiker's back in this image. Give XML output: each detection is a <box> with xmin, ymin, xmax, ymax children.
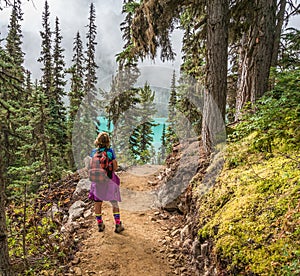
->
<box><xmin>89</xmin><ymin>150</ymin><xmax>113</xmax><ymax>183</ymax></box>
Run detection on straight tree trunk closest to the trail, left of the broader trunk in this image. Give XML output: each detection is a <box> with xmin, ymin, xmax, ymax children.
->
<box><xmin>202</xmin><ymin>0</ymin><xmax>229</xmax><ymax>154</ymax></box>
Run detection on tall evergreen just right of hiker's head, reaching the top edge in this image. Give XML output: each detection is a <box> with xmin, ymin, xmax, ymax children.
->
<box><xmin>106</xmin><ymin>0</ymin><xmax>140</xmax><ymax>158</ymax></box>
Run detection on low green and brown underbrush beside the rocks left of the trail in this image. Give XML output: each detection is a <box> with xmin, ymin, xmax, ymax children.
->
<box><xmin>7</xmin><ymin>174</ymin><xmax>79</xmax><ymax>275</ymax></box>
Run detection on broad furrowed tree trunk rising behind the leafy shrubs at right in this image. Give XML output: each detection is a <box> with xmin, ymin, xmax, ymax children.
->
<box><xmin>235</xmin><ymin>0</ymin><xmax>277</xmax><ymax>120</ymax></box>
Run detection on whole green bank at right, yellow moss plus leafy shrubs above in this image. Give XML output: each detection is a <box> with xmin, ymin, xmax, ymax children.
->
<box><xmin>195</xmin><ymin>70</ymin><xmax>300</xmax><ymax>275</ymax></box>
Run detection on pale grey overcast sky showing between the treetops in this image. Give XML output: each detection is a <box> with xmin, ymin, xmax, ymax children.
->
<box><xmin>0</xmin><ymin>0</ymin><xmax>181</xmax><ymax>87</ymax></box>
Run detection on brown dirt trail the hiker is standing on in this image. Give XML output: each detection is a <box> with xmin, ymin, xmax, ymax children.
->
<box><xmin>73</xmin><ymin>166</ymin><xmax>174</xmax><ymax>276</ymax></box>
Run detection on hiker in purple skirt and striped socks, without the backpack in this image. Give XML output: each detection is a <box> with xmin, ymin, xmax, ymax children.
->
<box><xmin>89</xmin><ymin>132</ymin><xmax>124</xmax><ymax>233</ymax></box>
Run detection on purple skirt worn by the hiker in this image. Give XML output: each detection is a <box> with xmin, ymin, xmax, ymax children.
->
<box><xmin>89</xmin><ymin>173</ymin><xmax>121</xmax><ymax>202</ymax></box>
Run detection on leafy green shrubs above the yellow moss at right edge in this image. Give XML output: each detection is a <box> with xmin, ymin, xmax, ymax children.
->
<box><xmin>229</xmin><ymin>70</ymin><xmax>300</xmax><ymax>153</ymax></box>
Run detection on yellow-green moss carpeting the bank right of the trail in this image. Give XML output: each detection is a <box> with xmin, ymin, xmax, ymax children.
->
<box><xmin>199</xmin><ymin>136</ymin><xmax>300</xmax><ymax>275</ymax></box>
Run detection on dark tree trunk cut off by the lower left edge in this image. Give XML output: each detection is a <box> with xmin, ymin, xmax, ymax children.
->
<box><xmin>0</xmin><ymin>155</ymin><xmax>13</xmax><ymax>276</ymax></box>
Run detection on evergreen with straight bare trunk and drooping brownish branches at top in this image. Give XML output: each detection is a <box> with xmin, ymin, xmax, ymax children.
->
<box><xmin>130</xmin><ymin>0</ymin><xmax>229</xmax><ymax>152</ymax></box>
